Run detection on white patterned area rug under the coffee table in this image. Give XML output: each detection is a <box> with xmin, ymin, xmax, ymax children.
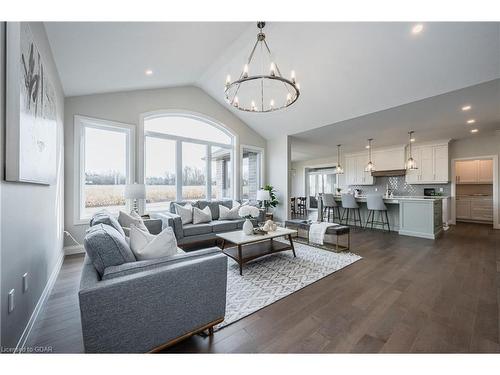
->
<box><xmin>215</xmin><ymin>242</ymin><xmax>361</xmax><ymax>329</ymax></box>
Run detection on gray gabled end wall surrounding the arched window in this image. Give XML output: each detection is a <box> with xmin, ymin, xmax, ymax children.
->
<box><xmin>64</xmin><ymin>86</ymin><xmax>266</xmax><ymax>246</ymax></box>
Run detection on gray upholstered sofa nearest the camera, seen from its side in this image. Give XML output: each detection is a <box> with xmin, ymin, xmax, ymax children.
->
<box><xmin>78</xmin><ymin>215</ymin><xmax>227</xmax><ymax>353</ymax></box>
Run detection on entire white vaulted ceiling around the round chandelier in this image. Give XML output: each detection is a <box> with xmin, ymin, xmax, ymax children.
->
<box><xmin>46</xmin><ymin>22</ymin><xmax>500</xmax><ymax>139</ymax></box>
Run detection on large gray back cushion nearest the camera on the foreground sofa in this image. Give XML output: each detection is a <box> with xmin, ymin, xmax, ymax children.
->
<box><xmin>84</xmin><ymin>224</ymin><xmax>136</xmax><ymax>276</ymax></box>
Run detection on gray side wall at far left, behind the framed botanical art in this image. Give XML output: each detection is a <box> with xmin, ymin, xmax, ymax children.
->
<box><xmin>0</xmin><ymin>22</ymin><xmax>64</xmax><ymax>347</ymax></box>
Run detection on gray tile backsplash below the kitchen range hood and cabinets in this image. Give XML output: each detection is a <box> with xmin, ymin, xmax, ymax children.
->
<box><xmin>349</xmin><ymin>176</ymin><xmax>451</xmax><ymax>196</ymax></box>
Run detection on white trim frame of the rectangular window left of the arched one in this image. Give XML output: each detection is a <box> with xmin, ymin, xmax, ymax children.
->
<box><xmin>73</xmin><ymin>115</ymin><xmax>136</xmax><ymax>225</ymax></box>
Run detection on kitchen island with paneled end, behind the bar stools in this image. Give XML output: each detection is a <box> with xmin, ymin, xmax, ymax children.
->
<box><xmin>335</xmin><ymin>195</ymin><xmax>447</xmax><ymax>239</ymax></box>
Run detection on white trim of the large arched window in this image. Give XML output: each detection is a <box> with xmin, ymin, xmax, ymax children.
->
<box><xmin>137</xmin><ymin>109</ymin><xmax>240</xmax><ymax>212</ymax></box>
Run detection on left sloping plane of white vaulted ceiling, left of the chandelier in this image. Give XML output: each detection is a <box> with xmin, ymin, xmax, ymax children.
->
<box><xmin>45</xmin><ymin>22</ymin><xmax>250</xmax><ymax>96</ymax></box>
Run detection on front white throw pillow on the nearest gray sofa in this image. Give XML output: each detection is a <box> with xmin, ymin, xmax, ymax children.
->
<box><xmin>130</xmin><ymin>225</ymin><xmax>178</xmax><ymax>260</ymax></box>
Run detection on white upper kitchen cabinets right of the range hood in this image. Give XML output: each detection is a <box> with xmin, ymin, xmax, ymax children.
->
<box><xmin>406</xmin><ymin>141</ymin><xmax>450</xmax><ymax>184</ymax></box>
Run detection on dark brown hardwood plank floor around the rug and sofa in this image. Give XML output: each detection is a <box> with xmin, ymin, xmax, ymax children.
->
<box><xmin>28</xmin><ymin>223</ymin><xmax>500</xmax><ymax>353</ymax></box>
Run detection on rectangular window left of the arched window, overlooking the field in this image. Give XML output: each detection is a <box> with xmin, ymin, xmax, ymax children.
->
<box><xmin>75</xmin><ymin>116</ymin><xmax>134</xmax><ymax>222</ymax></box>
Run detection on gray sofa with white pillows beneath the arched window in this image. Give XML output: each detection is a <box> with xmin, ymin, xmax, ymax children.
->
<box><xmin>150</xmin><ymin>200</ymin><xmax>265</xmax><ymax>246</ymax></box>
